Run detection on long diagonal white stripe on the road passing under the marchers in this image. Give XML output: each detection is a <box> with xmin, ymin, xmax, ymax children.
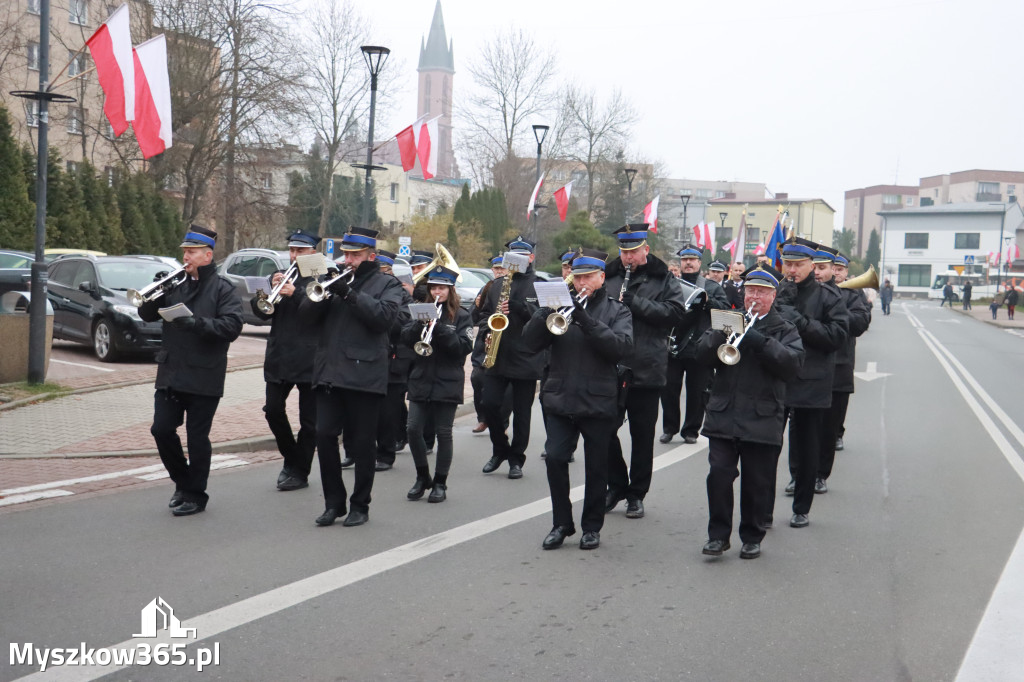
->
<box><xmin>12</xmin><ymin>444</ymin><xmax>707</xmax><ymax>680</ymax></box>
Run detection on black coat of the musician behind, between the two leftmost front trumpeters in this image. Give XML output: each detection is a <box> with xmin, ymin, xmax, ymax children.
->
<box><xmin>250</xmin><ymin>276</ymin><xmax>319</xmax><ymax>384</ymax></box>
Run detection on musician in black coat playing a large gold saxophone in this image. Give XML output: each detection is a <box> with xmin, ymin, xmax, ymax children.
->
<box><xmin>477</xmin><ymin>237</ymin><xmax>547</xmax><ymax>478</ymax></box>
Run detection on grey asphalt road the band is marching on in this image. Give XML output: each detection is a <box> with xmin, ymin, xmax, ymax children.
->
<box><xmin>0</xmin><ymin>303</ymin><xmax>1024</xmax><ymax>680</ymax></box>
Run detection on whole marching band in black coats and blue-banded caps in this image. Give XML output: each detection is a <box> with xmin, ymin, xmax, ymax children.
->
<box><xmin>146</xmin><ymin>223</ymin><xmax>878</xmax><ymax>559</ymax></box>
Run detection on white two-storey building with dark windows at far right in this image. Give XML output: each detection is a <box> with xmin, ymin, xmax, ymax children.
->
<box><xmin>879</xmin><ymin>202</ymin><xmax>1024</xmax><ymax>296</ymax></box>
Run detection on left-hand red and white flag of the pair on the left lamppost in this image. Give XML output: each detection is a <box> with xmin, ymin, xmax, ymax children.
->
<box><xmin>85</xmin><ymin>5</ymin><xmax>135</xmax><ymax>136</ymax></box>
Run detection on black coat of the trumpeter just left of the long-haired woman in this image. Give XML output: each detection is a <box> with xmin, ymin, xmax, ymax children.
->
<box><xmin>299</xmin><ymin>260</ymin><xmax>404</xmax><ymax>395</ymax></box>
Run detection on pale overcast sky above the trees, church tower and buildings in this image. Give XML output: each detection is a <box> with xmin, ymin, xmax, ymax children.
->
<box><xmin>356</xmin><ymin>0</ymin><xmax>1024</xmax><ymax>226</ymax></box>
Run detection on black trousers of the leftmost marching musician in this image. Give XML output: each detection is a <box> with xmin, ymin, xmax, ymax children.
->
<box><xmin>150</xmin><ymin>388</ymin><xmax>220</xmax><ymax>503</ymax></box>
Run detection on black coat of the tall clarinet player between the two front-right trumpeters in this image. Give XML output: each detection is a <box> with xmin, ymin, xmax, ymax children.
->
<box><xmin>604</xmin><ymin>254</ymin><xmax>686</xmax><ymax>388</ymax></box>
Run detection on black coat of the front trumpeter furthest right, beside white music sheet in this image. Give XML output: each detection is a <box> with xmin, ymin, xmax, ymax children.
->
<box><xmin>697</xmin><ymin>308</ymin><xmax>804</xmax><ymax>445</ymax></box>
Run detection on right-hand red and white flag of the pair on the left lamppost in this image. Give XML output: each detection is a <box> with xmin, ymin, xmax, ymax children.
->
<box><xmin>132</xmin><ymin>34</ymin><xmax>171</xmax><ymax>159</ymax></box>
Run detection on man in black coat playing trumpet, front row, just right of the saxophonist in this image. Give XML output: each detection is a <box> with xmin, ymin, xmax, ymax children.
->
<box><xmin>522</xmin><ymin>249</ymin><xmax>633</xmax><ymax>550</ymax></box>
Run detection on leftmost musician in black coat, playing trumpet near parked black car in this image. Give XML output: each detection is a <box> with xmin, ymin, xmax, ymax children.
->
<box><xmin>138</xmin><ymin>225</ymin><xmax>242</xmax><ymax>516</ymax></box>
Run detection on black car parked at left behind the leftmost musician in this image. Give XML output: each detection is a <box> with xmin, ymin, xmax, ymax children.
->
<box><xmin>46</xmin><ymin>256</ymin><xmax>174</xmax><ymax>363</ymax></box>
